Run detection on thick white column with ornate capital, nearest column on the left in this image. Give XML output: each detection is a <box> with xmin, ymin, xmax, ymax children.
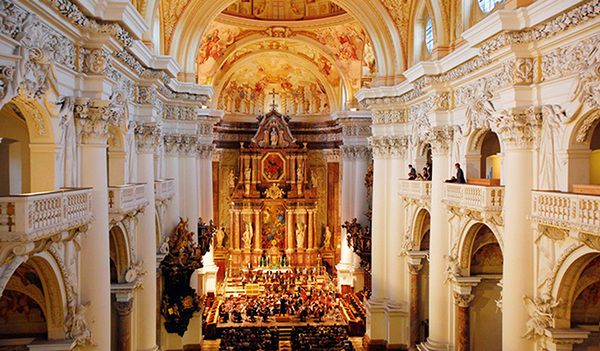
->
<box><xmin>75</xmin><ymin>99</ymin><xmax>112</xmax><ymax>350</ymax></box>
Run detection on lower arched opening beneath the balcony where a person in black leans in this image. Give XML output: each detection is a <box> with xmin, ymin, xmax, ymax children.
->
<box><xmin>463</xmin><ymin>223</ymin><xmax>503</xmax><ymax>351</ymax></box>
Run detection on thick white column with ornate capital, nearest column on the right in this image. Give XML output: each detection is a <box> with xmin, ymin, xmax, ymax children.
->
<box><xmin>500</xmin><ymin>110</ymin><xmax>537</xmax><ymax>351</ymax></box>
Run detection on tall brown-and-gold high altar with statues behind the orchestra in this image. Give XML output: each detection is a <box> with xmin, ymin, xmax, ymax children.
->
<box><xmin>217</xmin><ymin>109</ymin><xmax>331</xmax><ymax>268</ymax></box>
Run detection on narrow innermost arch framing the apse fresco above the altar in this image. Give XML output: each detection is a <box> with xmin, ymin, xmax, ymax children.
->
<box><xmin>212</xmin><ymin>50</ymin><xmax>343</xmax><ymax>111</ymax></box>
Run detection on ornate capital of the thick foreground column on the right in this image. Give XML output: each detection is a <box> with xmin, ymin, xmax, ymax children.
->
<box><xmin>496</xmin><ymin>107</ymin><xmax>542</xmax><ymax>150</ymax></box>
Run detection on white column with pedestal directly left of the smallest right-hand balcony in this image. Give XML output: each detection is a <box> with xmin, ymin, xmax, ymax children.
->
<box><xmin>386</xmin><ymin>151</ymin><xmax>410</xmax><ymax>349</ymax></box>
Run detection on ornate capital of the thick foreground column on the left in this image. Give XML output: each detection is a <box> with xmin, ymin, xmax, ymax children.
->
<box><xmin>74</xmin><ymin>98</ymin><xmax>112</xmax><ymax>145</ymax></box>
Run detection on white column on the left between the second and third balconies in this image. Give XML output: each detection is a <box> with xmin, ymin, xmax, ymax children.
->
<box><xmin>135</xmin><ymin>124</ymin><xmax>160</xmax><ymax>350</ymax></box>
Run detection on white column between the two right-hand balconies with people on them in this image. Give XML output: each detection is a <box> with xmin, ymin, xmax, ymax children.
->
<box><xmin>422</xmin><ymin>133</ymin><xmax>450</xmax><ymax>350</ymax></box>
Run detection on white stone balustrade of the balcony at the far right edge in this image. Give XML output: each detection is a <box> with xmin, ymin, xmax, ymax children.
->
<box><xmin>531</xmin><ymin>191</ymin><xmax>600</xmax><ymax>233</ymax></box>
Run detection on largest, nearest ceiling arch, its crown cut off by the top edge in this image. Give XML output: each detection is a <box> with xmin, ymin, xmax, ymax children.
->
<box><xmin>168</xmin><ymin>0</ymin><xmax>405</xmax><ymax>85</ymax></box>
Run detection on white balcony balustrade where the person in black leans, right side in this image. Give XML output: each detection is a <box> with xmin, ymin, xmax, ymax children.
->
<box><xmin>444</xmin><ymin>183</ymin><xmax>504</xmax><ymax>212</ymax></box>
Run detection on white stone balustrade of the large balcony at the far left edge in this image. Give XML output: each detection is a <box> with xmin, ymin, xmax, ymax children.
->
<box><xmin>0</xmin><ymin>188</ymin><xmax>93</xmax><ymax>241</ymax></box>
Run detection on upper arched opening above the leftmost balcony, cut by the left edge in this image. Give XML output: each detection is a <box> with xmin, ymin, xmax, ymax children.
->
<box><xmin>0</xmin><ymin>103</ymin><xmax>31</xmax><ymax>195</ymax></box>
